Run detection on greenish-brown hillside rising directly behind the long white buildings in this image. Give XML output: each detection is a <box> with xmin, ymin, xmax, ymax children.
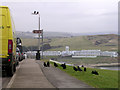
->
<box><xmin>22</xmin><ymin>34</ymin><xmax>118</xmax><ymax>51</ymax></box>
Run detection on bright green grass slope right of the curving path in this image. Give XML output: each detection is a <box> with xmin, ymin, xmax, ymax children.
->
<box><xmin>51</xmin><ymin>62</ymin><xmax>118</xmax><ymax>88</ymax></box>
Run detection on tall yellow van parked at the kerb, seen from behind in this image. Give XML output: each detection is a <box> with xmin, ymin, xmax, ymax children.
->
<box><xmin>0</xmin><ymin>6</ymin><xmax>16</xmax><ymax>76</ymax></box>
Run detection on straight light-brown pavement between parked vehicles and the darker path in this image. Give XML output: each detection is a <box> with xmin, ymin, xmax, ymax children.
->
<box><xmin>10</xmin><ymin>59</ymin><xmax>54</xmax><ymax>89</ymax></box>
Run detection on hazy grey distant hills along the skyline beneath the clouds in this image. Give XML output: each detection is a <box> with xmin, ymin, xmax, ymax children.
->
<box><xmin>16</xmin><ymin>31</ymin><xmax>117</xmax><ymax>39</ymax></box>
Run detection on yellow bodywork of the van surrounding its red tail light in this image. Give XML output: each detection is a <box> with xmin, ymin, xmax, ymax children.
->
<box><xmin>0</xmin><ymin>7</ymin><xmax>16</xmax><ymax>58</ymax></box>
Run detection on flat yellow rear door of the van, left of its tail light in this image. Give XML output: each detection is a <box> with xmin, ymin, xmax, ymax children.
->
<box><xmin>0</xmin><ymin>8</ymin><xmax>8</xmax><ymax>57</ymax></box>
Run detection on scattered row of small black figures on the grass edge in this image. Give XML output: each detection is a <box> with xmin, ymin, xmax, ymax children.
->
<box><xmin>43</xmin><ymin>61</ymin><xmax>99</xmax><ymax>75</ymax></box>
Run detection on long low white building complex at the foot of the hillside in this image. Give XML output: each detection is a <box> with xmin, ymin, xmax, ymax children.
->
<box><xmin>26</xmin><ymin>46</ymin><xmax>118</xmax><ymax>57</ymax></box>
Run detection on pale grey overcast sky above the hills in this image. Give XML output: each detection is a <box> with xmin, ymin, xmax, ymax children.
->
<box><xmin>2</xmin><ymin>0</ymin><xmax>118</xmax><ymax>33</ymax></box>
